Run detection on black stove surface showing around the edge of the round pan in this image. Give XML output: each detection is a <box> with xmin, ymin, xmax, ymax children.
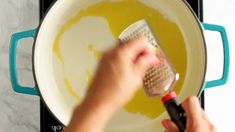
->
<box><xmin>40</xmin><ymin>0</ymin><xmax>204</xmax><ymax>132</ymax></box>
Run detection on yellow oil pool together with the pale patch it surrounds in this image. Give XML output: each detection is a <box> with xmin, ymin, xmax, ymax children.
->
<box><xmin>53</xmin><ymin>0</ymin><xmax>187</xmax><ymax>118</ymax></box>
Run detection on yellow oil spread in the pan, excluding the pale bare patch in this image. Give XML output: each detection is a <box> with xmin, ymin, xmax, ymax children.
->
<box><xmin>53</xmin><ymin>0</ymin><xmax>187</xmax><ymax>118</ymax></box>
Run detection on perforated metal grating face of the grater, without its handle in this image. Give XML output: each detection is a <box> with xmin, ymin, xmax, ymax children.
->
<box><xmin>119</xmin><ymin>20</ymin><xmax>179</xmax><ymax>97</ymax></box>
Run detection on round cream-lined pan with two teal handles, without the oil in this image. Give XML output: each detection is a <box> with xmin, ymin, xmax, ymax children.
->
<box><xmin>9</xmin><ymin>0</ymin><xmax>230</xmax><ymax>132</ymax></box>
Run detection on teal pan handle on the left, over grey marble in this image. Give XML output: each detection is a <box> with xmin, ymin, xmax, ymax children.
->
<box><xmin>9</xmin><ymin>29</ymin><xmax>38</xmax><ymax>95</ymax></box>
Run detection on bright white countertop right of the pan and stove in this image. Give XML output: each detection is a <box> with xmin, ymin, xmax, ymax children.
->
<box><xmin>204</xmin><ymin>0</ymin><xmax>235</xmax><ymax>132</ymax></box>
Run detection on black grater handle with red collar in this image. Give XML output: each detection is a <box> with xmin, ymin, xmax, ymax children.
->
<box><xmin>163</xmin><ymin>93</ymin><xmax>186</xmax><ymax>132</ymax></box>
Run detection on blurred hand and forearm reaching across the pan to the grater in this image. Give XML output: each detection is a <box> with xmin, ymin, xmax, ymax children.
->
<box><xmin>66</xmin><ymin>36</ymin><xmax>159</xmax><ymax>132</ymax></box>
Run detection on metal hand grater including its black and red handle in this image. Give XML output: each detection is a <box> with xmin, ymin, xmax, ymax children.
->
<box><xmin>119</xmin><ymin>19</ymin><xmax>186</xmax><ymax>132</ymax></box>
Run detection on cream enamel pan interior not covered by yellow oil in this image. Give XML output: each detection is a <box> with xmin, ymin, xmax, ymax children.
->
<box><xmin>34</xmin><ymin>0</ymin><xmax>206</xmax><ymax>131</ymax></box>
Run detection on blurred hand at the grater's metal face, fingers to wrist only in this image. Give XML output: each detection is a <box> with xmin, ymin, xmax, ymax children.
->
<box><xmin>85</xmin><ymin>36</ymin><xmax>159</xmax><ymax>108</ymax></box>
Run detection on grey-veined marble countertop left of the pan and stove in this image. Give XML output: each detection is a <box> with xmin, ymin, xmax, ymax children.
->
<box><xmin>0</xmin><ymin>0</ymin><xmax>40</xmax><ymax>132</ymax></box>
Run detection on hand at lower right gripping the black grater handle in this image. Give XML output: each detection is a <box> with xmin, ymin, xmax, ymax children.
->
<box><xmin>162</xmin><ymin>97</ymin><xmax>216</xmax><ymax>132</ymax></box>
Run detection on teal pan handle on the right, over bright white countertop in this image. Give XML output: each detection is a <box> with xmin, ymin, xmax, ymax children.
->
<box><xmin>202</xmin><ymin>23</ymin><xmax>230</xmax><ymax>89</ymax></box>
